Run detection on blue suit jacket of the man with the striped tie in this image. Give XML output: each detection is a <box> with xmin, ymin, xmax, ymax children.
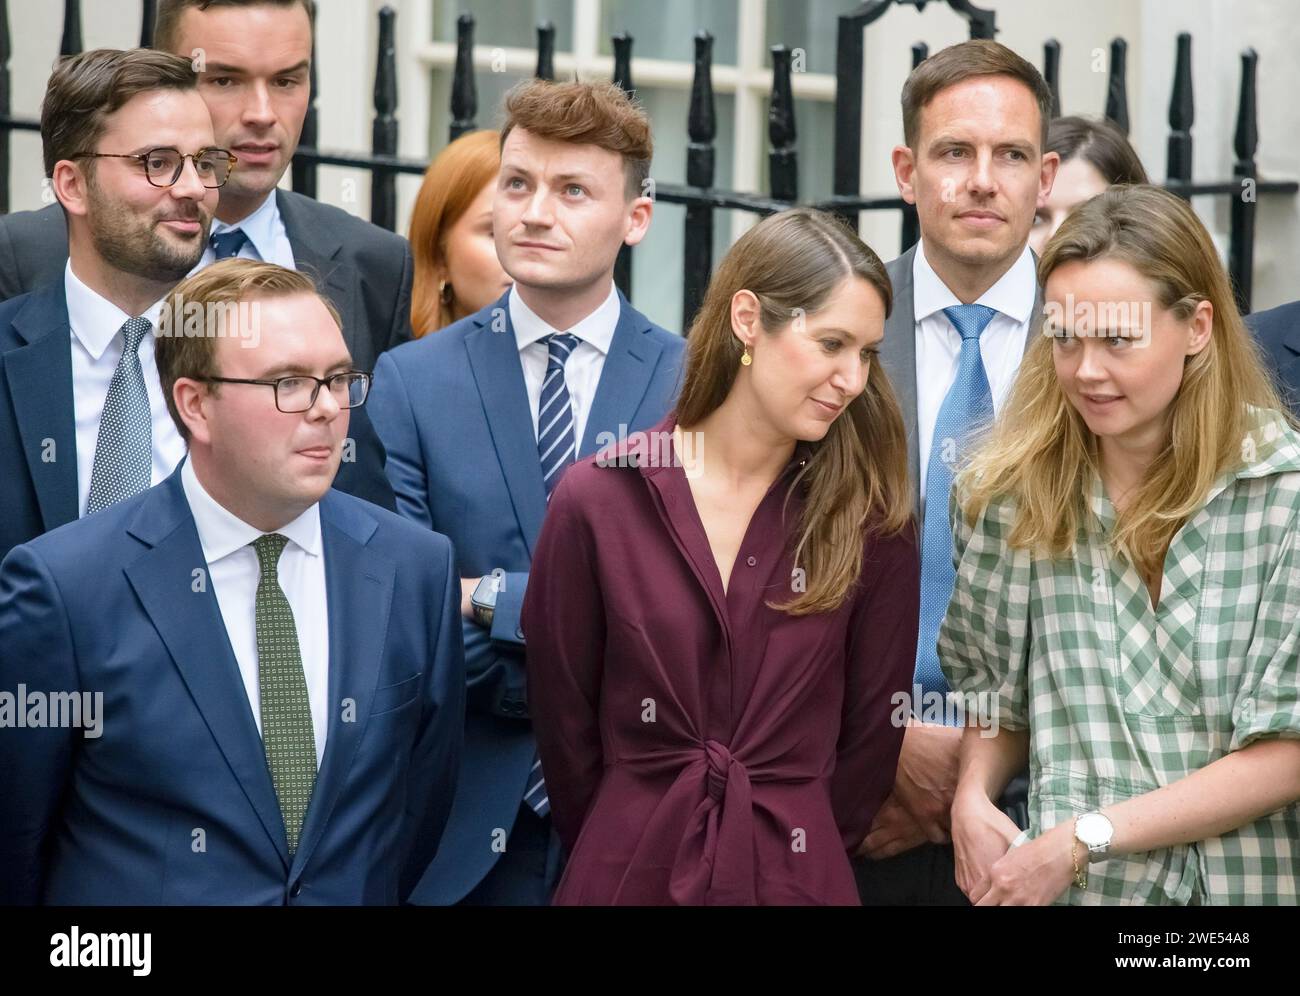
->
<box><xmin>369</xmin><ymin>294</ymin><xmax>685</xmax><ymax>904</ymax></box>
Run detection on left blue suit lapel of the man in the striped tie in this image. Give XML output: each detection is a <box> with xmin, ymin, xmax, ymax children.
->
<box><xmin>465</xmin><ymin>293</ymin><xmax>548</xmax><ymax>558</ymax></box>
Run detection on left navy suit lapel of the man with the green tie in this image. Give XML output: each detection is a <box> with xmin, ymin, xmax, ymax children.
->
<box><xmin>126</xmin><ymin>468</ymin><xmax>289</xmax><ymax>870</ymax></box>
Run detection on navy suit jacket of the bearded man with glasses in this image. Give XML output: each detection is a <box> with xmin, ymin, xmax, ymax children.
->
<box><xmin>0</xmin><ymin>277</ymin><xmax>395</xmax><ymax>559</ymax></box>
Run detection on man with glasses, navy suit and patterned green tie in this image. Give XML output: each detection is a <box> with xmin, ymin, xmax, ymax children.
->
<box><xmin>0</xmin><ymin>260</ymin><xmax>465</xmax><ymax>905</ymax></box>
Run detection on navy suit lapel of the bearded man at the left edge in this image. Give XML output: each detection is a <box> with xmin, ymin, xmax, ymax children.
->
<box><xmin>4</xmin><ymin>281</ymin><xmax>79</xmax><ymax>532</ymax></box>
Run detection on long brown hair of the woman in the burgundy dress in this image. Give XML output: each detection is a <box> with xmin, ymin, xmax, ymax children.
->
<box><xmin>676</xmin><ymin>208</ymin><xmax>911</xmax><ymax>615</ymax></box>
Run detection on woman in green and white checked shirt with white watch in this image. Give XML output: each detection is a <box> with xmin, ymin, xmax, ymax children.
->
<box><xmin>939</xmin><ymin>186</ymin><xmax>1300</xmax><ymax>905</ymax></box>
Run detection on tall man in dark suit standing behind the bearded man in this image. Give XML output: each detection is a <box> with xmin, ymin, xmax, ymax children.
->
<box><xmin>0</xmin><ymin>0</ymin><xmax>412</xmax><ymax>374</ymax></box>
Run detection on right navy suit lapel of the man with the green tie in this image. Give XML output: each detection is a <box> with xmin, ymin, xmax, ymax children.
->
<box><xmin>294</xmin><ymin>493</ymin><xmax>395</xmax><ymax>871</ymax></box>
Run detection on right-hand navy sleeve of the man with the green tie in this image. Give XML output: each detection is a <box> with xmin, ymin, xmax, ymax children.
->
<box><xmin>399</xmin><ymin>536</ymin><xmax>465</xmax><ymax>901</ymax></box>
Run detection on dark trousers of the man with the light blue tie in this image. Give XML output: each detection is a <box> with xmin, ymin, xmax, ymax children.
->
<box><xmin>853</xmin><ymin>768</ymin><xmax>1030</xmax><ymax>906</ymax></box>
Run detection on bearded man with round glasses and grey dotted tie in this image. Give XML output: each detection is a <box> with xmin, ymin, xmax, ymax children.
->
<box><xmin>0</xmin><ymin>49</ymin><xmax>393</xmax><ymax>569</ymax></box>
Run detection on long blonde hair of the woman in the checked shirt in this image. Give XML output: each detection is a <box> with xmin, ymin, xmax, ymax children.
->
<box><xmin>957</xmin><ymin>186</ymin><xmax>1290</xmax><ymax>577</ymax></box>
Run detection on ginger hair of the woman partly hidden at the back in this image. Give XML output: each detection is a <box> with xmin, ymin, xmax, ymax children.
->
<box><xmin>410</xmin><ymin>131</ymin><xmax>501</xmax><ymax>338</ymax></box>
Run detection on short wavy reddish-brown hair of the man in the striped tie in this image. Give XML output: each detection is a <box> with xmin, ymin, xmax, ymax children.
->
<box><xmin>501</xmin><ymin>79</ymin><xmax>654</xmax><ymax>198</ymax></box>
